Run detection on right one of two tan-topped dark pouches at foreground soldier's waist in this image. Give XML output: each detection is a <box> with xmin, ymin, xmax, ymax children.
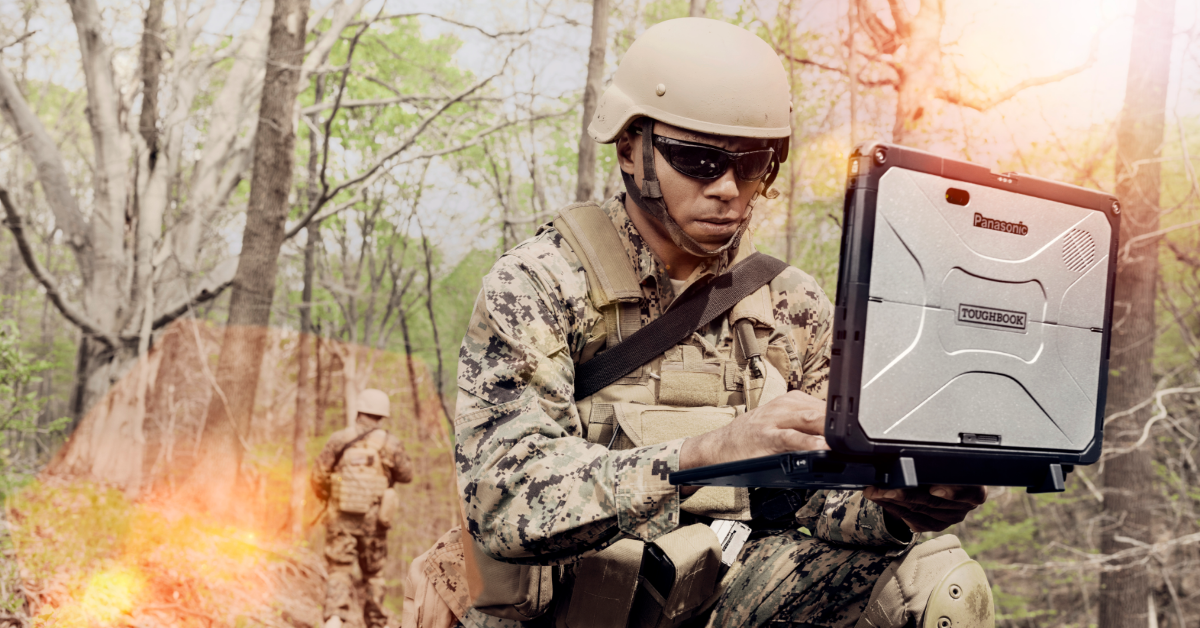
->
<box><xmin>629</xmin><ymin>524</ymin><xmax>721</xmax><ymax>628</ymax></box>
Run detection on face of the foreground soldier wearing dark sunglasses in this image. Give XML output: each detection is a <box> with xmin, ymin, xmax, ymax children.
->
<box><xmin>617</xmin><ymin>122</ymin><xmax>766</xmax><ymax>250</ymax></box>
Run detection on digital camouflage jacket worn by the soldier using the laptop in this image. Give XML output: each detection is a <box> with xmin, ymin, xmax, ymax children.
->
<box><xmin>455</xmin><ymin>195</ymin><xmax>907</xmax><ymax>564</ymax></box>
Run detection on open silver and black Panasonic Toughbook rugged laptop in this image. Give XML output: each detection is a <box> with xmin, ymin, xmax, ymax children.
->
<box><xmin>671</xmin><ymin>143</ymin><xmax>1121</xmax><ymax>491</ymax></box>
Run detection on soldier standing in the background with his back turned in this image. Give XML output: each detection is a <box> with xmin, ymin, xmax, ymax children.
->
<box><xmin>312</xmin><ymin>388</ymin><xmax>413</xmax><ymax>628</ymax></box>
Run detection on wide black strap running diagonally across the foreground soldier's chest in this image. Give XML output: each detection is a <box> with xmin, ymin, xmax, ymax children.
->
<box><xmin>575</xmin><ymin>252</ymin><xmax>787</xmax><ymax>401</ymax></box>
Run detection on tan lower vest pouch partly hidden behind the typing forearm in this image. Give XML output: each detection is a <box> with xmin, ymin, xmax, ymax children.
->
<box><xmin>613</xmin><ymin>403</ymin><xmax>750</xmax><ymax>521</ymax></box>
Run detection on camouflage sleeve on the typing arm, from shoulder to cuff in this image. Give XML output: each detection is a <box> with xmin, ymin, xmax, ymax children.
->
<box><xmin>455</xmin><ymin>240</ymin><xmax>683</xmax><ymax>564</ymax></box>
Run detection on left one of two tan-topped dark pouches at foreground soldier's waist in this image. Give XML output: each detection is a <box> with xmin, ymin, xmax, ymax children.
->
<box><xmin>565</xmin><ymin>539</ymin><xmax>646</xmax><ymax>628</ymax></box>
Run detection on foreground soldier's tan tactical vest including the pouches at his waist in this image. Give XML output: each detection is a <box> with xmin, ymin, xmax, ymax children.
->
<box><xmin>553</xmin><ymin>203</ymin><xmax>791</xmax><ymax>628</ymax></box>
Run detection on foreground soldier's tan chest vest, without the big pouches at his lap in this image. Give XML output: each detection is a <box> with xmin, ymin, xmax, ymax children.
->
<box><xmin>553</xmin><ymin>203</ymin><xmax>791</xmax><ymax>521</ymax></box>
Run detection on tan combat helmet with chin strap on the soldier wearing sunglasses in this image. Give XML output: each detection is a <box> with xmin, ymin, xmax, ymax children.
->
<box><xmin>588</xmin><ymin>18</ymin><xmax>792</xmax><ymax>257</ymax></box>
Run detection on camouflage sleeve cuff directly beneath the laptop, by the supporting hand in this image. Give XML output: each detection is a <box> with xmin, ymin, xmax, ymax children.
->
<box><xmin>796</xmin><ymin>491</ymin><xmax>919</xmax><ymax>552</ymax></box>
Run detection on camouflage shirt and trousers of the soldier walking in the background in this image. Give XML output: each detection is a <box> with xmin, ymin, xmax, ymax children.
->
<box><xmin>312</xmin><ymin>417</ymin><xmax>413</xmax><ymax>628</ymax></box>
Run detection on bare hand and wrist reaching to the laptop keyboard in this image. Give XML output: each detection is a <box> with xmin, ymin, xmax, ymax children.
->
<box><xmin>679</xmin><ymin>390</ymin><xmax>829</xmax><ymax>469</ymax></box>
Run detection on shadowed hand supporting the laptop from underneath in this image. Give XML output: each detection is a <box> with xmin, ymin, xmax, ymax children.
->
<box><xmin>863</xmin><ymin>485</ymin><xmax>988</xmax><ymax>532</ymax></box>
